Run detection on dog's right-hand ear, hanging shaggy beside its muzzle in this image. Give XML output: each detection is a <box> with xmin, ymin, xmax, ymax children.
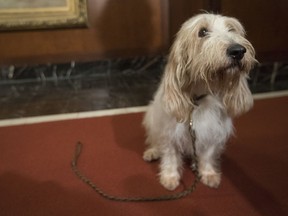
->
<box><xmin>224</xmin><ymin>74</ymin><xmax>254</xmax><ymax>117</ymax></box>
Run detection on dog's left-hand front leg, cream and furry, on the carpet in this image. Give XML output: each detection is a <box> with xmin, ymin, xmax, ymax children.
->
<box><xmin>159</xmin><ymin>146</ymin><xmax>182</xmax><ymax>190</ymax></box>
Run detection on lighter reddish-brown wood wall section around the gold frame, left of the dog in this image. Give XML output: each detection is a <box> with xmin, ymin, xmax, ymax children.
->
<box><xmin>0</xmin><ymin>0</ymin><xmax>167</xmax><ymax>64</ymax></box>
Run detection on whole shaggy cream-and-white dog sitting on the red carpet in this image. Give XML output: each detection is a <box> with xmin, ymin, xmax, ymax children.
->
<box><xmin>143</xmin><ymin>13</ymin><xmax>257</xmax><ymax>190</ymax></box>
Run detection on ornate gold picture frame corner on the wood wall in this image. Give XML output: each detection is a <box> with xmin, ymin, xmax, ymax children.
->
<box><xmin>0</xmin><ymin>0</ymin><xmax>88</xmax><ymax>31</ymax></box>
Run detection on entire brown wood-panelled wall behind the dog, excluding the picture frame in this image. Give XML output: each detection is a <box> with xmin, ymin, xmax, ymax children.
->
<box><xmin>0</xmin><ymin>0</ymin><xmax>288</xmax><ymax>65</ymax></box>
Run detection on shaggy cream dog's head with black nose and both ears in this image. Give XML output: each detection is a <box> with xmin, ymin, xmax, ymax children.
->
<box><xmin>163</xmin><ymin>14</ymin><xmax>257</xmax><ymax>120</ymax></box>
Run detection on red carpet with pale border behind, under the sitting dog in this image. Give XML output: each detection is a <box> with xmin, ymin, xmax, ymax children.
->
<box><xmin>0</xmin><ymin>97</ymin><xmax>288</xmax><ymax>216</ymax></box>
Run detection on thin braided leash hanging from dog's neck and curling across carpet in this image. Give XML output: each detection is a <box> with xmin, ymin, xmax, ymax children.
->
<box><xmin>71</xmin><ymin>120</ymin><xmax>201</xmax><ymax>202</ymax></box>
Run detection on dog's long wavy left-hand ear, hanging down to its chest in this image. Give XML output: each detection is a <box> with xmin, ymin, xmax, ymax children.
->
<box><xmin>162</xmin><ymin>34</ymin><xmax>193</xmax><ymax>122</ymax></box>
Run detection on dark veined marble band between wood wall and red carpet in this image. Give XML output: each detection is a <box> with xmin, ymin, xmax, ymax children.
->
<box><xmin>0</xmin><ymin>56</ymin><xmax>288</xmax><ymax>119</ymax></box>
